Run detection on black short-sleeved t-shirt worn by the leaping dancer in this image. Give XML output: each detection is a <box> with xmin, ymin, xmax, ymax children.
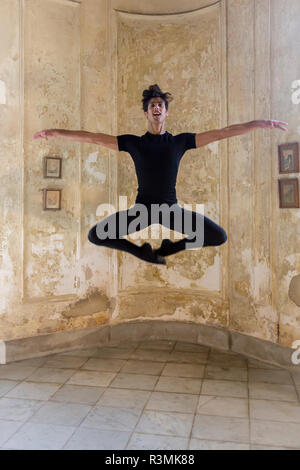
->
<box><xmin>117</xmin><ymin>131</ymin><xmax>196</xmax><ymax>205</ymax></box>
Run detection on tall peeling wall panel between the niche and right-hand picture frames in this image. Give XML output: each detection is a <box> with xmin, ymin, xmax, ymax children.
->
<box><xmin>227</xmin><ymin>0</ymin><xmax>274</xmax><ymax>342</ymax></box>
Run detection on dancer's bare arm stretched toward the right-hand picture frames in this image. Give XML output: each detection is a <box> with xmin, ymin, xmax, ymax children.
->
<box><xmin>196</xmin><ymin>120</ymin><xmax>288</xmax><ymax>147</ymax></box>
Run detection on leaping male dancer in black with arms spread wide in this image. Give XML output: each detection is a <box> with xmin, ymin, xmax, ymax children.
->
<box><xmin>34</xmin><ymin>84</ymin><xmax>288</xmax><ymax>264</ymax></box>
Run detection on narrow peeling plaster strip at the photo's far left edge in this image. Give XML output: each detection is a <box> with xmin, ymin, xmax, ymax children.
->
<box><xmin>0</xmin><ymin>0</ymin><xmax>22</xmax><ymax>324</ymax></box>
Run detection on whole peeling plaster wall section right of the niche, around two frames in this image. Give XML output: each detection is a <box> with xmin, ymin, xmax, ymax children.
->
<box><xmin>228</xmin><ymin>0</ymin><xmax>300</xmax><ymax>346</ymax></box>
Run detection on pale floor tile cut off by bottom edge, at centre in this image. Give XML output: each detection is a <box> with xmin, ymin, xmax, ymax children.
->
<box><xmin>126</xmin><ymin>433</ymin><xmax>188</xmax><ymax>450</ymax></box>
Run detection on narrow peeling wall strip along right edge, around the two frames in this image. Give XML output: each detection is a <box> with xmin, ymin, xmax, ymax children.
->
<box><xmin>271</xmin><ymin>0</ymin><xmax>300</xmax><ymax>345</ymax></box>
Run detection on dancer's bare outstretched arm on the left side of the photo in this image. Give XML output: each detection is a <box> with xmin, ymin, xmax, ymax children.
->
<box><xmin>33</xmin><ymin>129</ymin><xmax>118</xmax><ymax>150</ymax></box>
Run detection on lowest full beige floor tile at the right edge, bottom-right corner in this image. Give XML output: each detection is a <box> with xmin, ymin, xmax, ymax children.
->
<box><xmin>250</xmin><ymin>419</ymin><xmax>300</xmax><ymax>448</ymax></box>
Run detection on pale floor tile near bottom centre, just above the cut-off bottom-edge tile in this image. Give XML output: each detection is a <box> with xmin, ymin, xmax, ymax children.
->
<box><xmin>135</xmin><ymin>411</ymin><xmax>193</xmax><ymax>437</ymax></box>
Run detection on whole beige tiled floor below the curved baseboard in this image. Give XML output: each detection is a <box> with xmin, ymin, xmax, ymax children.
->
<box><xmin>0</xmin><ymin>341</ymin><xmax>300</xmax><ymax>450</ymax></box>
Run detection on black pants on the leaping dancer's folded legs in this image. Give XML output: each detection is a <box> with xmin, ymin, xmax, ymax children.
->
<box><xmin>88</xmin><ymin>204</ymin><xmax>227</xmax><ymax>256</ymax></box>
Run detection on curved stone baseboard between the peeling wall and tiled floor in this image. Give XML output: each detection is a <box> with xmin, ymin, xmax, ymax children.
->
<box><xmin>0</xmin><ymin>320</ymin><xmax>300</xmax><ymax>371</ymax></box>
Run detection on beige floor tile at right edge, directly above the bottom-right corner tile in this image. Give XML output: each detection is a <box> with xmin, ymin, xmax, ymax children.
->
<box><xmin>249</xmin><ymin>399</ymin><xmax>300</xmax><ymax>423</ymax></box>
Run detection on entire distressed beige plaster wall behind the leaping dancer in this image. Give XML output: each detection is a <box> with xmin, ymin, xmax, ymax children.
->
<box><xmin>0</xmin><ymin>0</ymin><xmax>300</xmax><ymax>346</ymax></box>
